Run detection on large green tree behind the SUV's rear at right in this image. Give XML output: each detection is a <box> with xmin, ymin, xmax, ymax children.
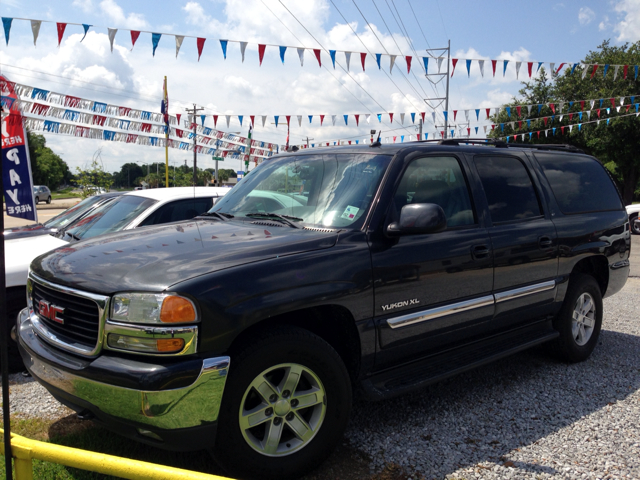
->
<box><xmin>489</xmin><ymin>40</ymin><xmax>640</xmax><ymax>204</ymax></box>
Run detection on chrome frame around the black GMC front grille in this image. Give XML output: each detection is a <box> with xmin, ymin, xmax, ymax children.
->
<box><xmin>27</xmin><ymin>271</ymin><xmax>110</xmax><ymax>357</ymax></box>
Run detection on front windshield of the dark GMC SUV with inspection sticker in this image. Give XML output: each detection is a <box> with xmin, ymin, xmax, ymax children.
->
<box><xmin>210</xmin><ymin>154</ymin><xmax>391</xmax><ymax>228</ymax></box>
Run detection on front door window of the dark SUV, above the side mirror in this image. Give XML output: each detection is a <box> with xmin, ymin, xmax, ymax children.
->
<box><xmin>394</xmin><ymin>157</ymin><xmax>475</xmax><ymax>227</ymax></box>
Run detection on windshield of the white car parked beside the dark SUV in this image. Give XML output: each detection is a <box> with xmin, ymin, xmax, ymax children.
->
<box><xmin>66</xmin><ymin>195</ymin><xmax>156</xmax><ymax>240</ymax></box>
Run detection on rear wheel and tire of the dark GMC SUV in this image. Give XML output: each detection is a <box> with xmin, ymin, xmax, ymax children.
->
<box><xmin>555</xmin><ymin>273</ymin><xmax>602</xmax><ymax>363</ymax></box>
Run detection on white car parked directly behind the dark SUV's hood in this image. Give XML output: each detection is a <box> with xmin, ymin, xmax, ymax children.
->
<box><xmin>4</xmin><ymin>187</ymin><xmax>231</xmax><ymax>368</ymax></box>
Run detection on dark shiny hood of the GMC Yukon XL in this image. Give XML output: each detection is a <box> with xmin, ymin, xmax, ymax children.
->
<box><xmin>31</xmin><ymin>219</ymin><xmax>338</xmax><ymax>294</ymax></box>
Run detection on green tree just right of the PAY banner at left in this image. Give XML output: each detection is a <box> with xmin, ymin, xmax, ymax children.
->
<box><xmin>27</xmin><ymin>132</ymin><xmax>72</xmax><ymax>191</ymax></box>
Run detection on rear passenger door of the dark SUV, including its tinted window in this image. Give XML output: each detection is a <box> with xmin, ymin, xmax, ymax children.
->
<box><xmin>474</xmin><ymin>153</ymin><xmax>558</xmax><ymax>329</ymax></box>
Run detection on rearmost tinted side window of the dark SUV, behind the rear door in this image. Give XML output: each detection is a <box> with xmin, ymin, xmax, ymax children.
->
<box><xmin>535</xmin><ymin>153</ymin><xmax>622</xmax><ymax>214</ymax></box>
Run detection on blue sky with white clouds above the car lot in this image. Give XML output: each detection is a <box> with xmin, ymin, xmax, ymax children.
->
<box><xmin>0</xmin><ymin>0</ymin><xmax>640</xmax><ymax>176</ymax></box>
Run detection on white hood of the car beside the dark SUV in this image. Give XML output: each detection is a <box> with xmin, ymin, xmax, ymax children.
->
<box><xmin>4</xmin><ymin>235</ymin><xmax>67</xmax><ymax>287</ymax></box>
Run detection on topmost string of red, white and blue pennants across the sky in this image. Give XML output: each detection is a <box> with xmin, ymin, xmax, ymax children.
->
<box><xmin>2</xmin><ymin>17</ymin><xmax>639</xmax><ymax>81</ymax></box>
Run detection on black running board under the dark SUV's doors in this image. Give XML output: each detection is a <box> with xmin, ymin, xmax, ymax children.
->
<box><xmin>362</xmin><ymin>324</ymin><xmax>559</xmax><ymax>400</ymax></box>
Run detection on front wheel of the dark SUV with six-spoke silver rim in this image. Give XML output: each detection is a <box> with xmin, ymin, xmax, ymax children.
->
<box><xmin>218</xmin><ymin>327</ymin><xmax>351</xmax><ymax>479</ymax></box>
